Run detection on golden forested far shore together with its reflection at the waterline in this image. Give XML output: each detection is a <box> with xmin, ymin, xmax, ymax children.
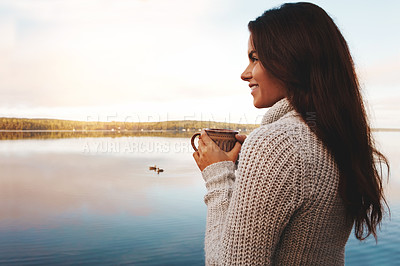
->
<box><xmin>0</xmin><ymin>117</ymin><xmax>259</xmax><ymax>140</ymax></box>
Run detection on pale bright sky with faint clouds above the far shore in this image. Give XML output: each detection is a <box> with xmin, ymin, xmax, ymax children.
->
<box><xmin>0</xmin><ymin>0</ymin><xmax>400</xmax><ymax>128</ymax></box>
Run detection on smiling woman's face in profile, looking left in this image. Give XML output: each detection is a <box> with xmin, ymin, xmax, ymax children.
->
<box><xmin>241</xmin><ymin>35</ymin><xmax>286</xmax><ymax>108</ymax></box>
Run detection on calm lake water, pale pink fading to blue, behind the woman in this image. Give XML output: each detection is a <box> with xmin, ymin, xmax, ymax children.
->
<box><xmin>0</xmin><ymin>132</ymin><xmax>400</xmax><ymax>265</ymax></box>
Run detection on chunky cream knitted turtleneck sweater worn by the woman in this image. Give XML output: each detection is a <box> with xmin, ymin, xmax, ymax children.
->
<box><xmin>202</xmin><ymin>98</ymin><xmax>353</xmax><ymax>265</ymax></box>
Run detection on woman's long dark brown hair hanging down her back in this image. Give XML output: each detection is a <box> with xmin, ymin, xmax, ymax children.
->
<box><xmin>248</xmin><ymin>3</ymin><xmax>389</xmax><ymax>240</ymax></box>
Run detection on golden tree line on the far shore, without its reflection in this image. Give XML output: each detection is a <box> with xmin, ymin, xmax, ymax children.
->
<box><xmin>0</xmin><ymin>117</ymin><xmax>259</xmax><ymax>132</ymax></box>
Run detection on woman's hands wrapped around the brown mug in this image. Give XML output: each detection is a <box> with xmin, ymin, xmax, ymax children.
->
<box><xmin>193</xmin><ymin>130</ymin><xmax>246</xmax><ymax>171</ymax></box>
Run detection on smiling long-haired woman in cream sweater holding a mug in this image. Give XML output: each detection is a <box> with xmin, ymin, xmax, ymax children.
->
<box><xmin>193</xmin><ymin>3</ymin><xmax>388</xmax><ymax>265</ymax></box>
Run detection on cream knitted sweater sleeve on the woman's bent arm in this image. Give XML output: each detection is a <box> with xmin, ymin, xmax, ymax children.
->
<box><xmin>202</xmin><ymin>130</ymin><xmax>304</xmax><ymax>265</ymax></box>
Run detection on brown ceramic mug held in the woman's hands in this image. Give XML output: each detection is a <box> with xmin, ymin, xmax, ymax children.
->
<box><xmin>191</xmin><ymin>128</ymin><xmax>239</xmax><ymax>152</ymax></box>
